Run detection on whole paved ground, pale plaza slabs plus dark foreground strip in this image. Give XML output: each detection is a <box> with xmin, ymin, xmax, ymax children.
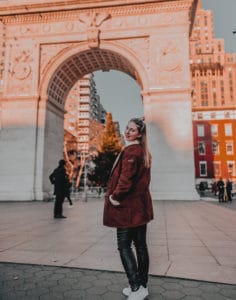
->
<box><xmin>0</xmin><ymin>198</ymin><xmax>236</xmax><ymax>300</ymax></box>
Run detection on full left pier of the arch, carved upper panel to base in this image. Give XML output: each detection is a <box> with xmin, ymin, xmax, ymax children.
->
<box><xmin>0</xmin><ymin>38</ymin><xmax>42</xmax><ymax>201</ymax></box>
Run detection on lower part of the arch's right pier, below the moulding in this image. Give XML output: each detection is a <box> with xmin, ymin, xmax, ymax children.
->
<box><xmin>143</xmin><ymin>89</ymin><xmax>199</xmax><ymax>200</ymax></box>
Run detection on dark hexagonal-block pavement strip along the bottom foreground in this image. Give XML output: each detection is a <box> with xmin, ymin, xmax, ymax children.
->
<box><xmin>0</xmin><ymin>263</ymin><xmax>236</xmax><ymax>300</ymax></box>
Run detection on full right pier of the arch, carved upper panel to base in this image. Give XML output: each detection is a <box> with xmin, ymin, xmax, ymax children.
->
<box><xmin>142</xmin><ymin>6</ymin><xmax>199</xmax><ymax>200</ymax></box>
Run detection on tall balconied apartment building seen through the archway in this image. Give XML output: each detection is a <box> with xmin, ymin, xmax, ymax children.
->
<box><xmin>64</xmin><ymin>74</ymin><xmax>106</xmax><ymax>154</ymax></box>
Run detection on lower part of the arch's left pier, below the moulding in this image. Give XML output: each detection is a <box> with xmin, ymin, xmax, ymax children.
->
<box><xmin>0</xmin><ymin>97</ymin><xmax>37</xmax><ymax>201</ymax></box>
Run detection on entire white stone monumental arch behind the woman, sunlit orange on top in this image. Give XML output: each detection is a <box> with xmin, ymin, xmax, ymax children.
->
<box><xmin>0</xmin><ymin>0</ymin><xmax>199</xmax><ymax>200</ymax></box>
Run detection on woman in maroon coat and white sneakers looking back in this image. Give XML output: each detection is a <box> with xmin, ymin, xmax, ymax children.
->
<box><xmin>103</xmin><ymin>118</ymin><xmax>153</xmax><ymax>300</ymax></box>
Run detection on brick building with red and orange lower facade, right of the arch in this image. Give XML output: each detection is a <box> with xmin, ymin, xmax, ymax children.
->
<box><xmin>190</xmin><ymin>1</ymin><xmax>236</xmax><ymax>188</ymax></box>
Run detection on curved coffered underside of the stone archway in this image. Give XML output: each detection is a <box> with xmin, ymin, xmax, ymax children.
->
<box><xmin>47</xmin><ymin>49</ymin><xmax>141</xmax><ymax>106</ymax></box>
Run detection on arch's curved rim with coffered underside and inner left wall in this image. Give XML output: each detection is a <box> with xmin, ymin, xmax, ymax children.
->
<box><xmin>36</xmin><ymin>42</ymin><xmax>148</xmax><ymax>198</ymax></box>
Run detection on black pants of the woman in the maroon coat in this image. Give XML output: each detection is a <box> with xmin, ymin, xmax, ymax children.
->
<box><xmin>117</xmin><ymin>224</ymin><xmax>149</xmax><ymax>291</ymax></box>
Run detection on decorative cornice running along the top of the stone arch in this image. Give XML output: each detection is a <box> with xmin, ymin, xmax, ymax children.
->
<box><xmin>0</xmin><ymin>0</ymin><xmax>193</xmax><ymax>24</ymax></box>
